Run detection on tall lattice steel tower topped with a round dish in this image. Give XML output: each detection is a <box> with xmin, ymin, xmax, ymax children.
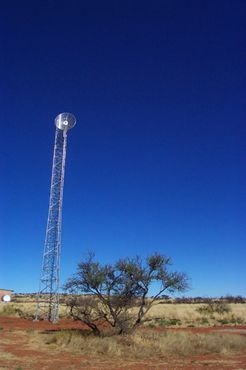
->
<box><xmin>36</xmin><ymin>113</ymin><xmax>76</xmax><ymax>322</ymax></box>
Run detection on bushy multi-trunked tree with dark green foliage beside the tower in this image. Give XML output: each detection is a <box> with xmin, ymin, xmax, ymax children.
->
<box><xmin>64</xmin><ymin>253</ymin><xmax>188</xmax><ymax>334</ymax></box>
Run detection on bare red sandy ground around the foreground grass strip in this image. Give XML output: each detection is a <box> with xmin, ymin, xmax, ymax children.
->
<box><xmin>0</xmin><ymin>317</ymin><xmax>246</xmax><ymax>370</ymax></box>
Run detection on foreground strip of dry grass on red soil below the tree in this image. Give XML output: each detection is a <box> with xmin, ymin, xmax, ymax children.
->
<box><xmin>41</xmin><ymin>331</ymin><xmax>246</xmax><ymax>359</ymax></box>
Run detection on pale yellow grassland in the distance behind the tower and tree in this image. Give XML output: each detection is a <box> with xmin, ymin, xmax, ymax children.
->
<box><xmin>0</xmin><ymin>295</ymin><xmax>246</xmax><ymax>328</ymax></box>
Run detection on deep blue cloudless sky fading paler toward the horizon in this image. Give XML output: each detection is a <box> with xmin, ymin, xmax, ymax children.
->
<box><xmin>0</xmin><ymin>0</ymin><xmax>246</xmax><ymax>296</ymax></box>
